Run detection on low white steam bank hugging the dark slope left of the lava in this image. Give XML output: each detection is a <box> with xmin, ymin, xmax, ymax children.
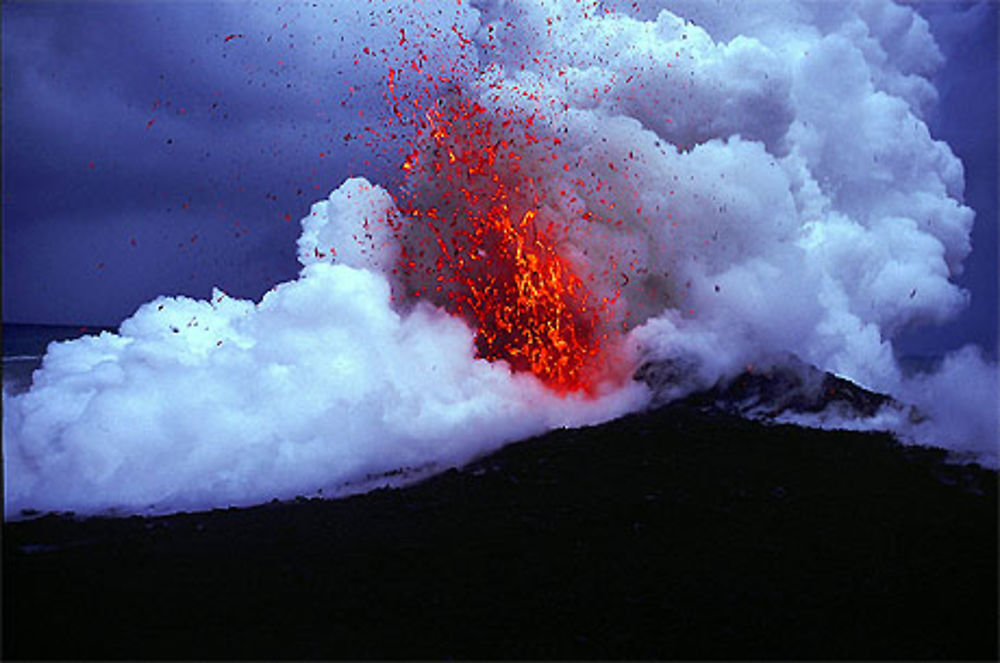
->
<box><xmin>4</xmin><ymin>256</ymin><xmax>643</xmax><ymax>513</ymax></box>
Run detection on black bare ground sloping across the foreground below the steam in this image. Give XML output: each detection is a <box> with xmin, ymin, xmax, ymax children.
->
<box><xmin>3</xmin><ymin>405</ymin><xmax>997</xmax><ymax>660</ymax></box>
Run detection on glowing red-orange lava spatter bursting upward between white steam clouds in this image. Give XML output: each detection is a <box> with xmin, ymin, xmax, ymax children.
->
<box><xmin>393</xmin><ymin>90</ymin><xmax>614</xmax><ymax>393</ymax></box>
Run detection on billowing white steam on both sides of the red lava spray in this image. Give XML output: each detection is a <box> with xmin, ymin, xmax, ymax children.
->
<box><xmin>3</xmin><ymin>0</ymin><xmax>998</xmax><ymax>514</ymax></box>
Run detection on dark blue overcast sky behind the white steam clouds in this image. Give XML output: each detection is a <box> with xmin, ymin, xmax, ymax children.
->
<box><xmin>3</xmin><ymin>2</ymin><xmax>998</xmax><ymax>355</ymax></box>
